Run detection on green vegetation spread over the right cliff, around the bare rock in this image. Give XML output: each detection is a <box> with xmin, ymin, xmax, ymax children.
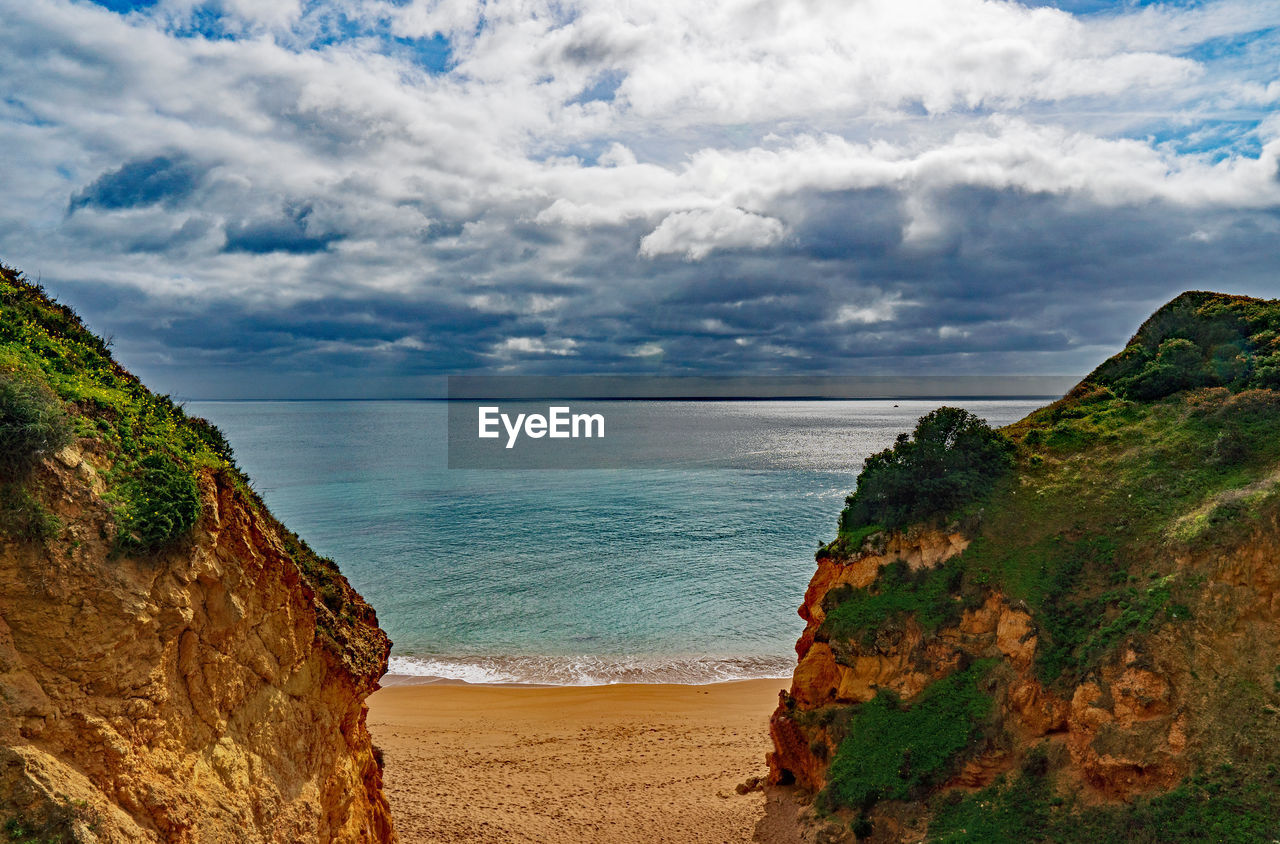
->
<box><xmin>796</xmin><ymin>293</ymin><xmax>1280</xmax><ymax>844</ymax></box>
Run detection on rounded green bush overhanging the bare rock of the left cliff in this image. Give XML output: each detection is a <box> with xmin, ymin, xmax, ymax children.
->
<box><xmin>116</xmin><ymin>455</ymin><xmax>200</xmax><ymax>553</ymax></box>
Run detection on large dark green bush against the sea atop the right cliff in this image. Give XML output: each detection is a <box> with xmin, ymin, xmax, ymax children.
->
<box><xmin>840</xmin><ymin>407</ymin><xmax>1014</xmax><ymax>533</ymax></box>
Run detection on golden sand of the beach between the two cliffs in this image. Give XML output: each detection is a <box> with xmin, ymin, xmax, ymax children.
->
<box><xmin>369</xmin><ymin>680</ymin><xmax>796</xmax><ymax>844</ymax></box>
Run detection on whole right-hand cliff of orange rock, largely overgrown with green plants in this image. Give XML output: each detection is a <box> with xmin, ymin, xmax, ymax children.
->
<box><xmin>769</xmin><ymin>293</ymin><xmax>1280</xmax><ymax>843</ymax></box>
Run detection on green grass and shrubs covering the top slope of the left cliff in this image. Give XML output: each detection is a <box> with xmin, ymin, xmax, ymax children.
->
<box><xmin>0</xmin><ymin>257</ymin><xmax>371</xmax><ymax>649</ymax></box>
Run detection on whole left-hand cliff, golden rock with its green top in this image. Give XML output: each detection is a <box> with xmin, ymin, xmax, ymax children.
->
<box><xmin>0</xmin><ymin>269</ymin><xmax>396</xmax><ymax>843</ymax></box>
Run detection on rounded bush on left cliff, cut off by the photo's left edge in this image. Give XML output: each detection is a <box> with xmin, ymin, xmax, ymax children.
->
<box><xmin>0</xmin><ymin>371</ymin><xmax>72</xmax><ymax>478</ymax></box>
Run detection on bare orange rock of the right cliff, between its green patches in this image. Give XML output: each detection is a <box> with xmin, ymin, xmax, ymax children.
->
<box><xmin>769</xmin><ymin>511</ymin><xmax>1280</xmax><ymax>841</ymax></box>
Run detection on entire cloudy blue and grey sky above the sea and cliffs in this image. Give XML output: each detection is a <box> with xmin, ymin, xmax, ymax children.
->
<box><xmin>0</xmin><ymin>0</ymin><xmax>1280</xmax><ymax>398</ymax></box>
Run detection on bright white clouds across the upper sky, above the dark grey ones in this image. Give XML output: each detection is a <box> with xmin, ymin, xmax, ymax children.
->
<box><xmin>0</xmin><ymin>0</ymin><xmax>1280</xmax><ymax>286</ymax></box>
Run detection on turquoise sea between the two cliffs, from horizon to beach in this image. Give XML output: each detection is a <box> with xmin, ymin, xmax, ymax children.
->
<box><xmin>187</xmin><ymin>400</ymin><xmax>1044</xmax><ymax>685</ymax></box>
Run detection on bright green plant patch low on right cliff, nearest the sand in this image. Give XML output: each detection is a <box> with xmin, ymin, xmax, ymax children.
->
<box><xmin>822</xmin><ymin>661</ymin><xmax>993</xmax><ymax>812</ymax></box>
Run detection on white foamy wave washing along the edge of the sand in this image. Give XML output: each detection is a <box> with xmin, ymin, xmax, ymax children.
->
<box><xmin>383</xmin><ymin>656</ymin><xmax>795</xmax><ymax>685</ymax></box>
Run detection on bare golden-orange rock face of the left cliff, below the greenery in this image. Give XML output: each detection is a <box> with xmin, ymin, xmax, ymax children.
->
<box><xmin>0</xmin><ymin>447</ymin><xmax>394</xmax><ymax>843</ymax></box>
